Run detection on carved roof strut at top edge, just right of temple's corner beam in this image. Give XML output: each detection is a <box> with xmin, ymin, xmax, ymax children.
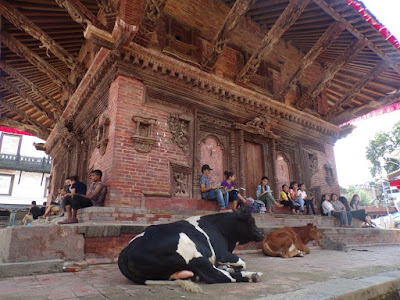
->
<box><xmin>134</xmin><ymin>0</ymin><xmax>167</xmax><ymax>47</ymax></box>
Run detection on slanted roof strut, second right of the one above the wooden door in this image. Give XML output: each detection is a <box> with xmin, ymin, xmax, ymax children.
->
<box><xmin>296</xmin><ymin>40</ymin><xmax>365</xmax><ymax>109</ymax></box>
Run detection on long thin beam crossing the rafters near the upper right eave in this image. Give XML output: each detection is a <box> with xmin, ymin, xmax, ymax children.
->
<box><xmin>313</xmin><ymin>0</ymin><xmax>400</xmax><ymax>74</ymax></box>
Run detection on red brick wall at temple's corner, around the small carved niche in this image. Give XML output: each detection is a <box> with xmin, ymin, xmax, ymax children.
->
<box><xmin>90</xmin><ymin>75</ymin><xmax>188</xmax><ymax>207</ymax></box>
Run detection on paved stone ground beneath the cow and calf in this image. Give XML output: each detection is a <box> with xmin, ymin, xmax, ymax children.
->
<box><xmin>0</xmin><ymin>246</ymin><xmax>400</xmax><ymax>300</ymax></box>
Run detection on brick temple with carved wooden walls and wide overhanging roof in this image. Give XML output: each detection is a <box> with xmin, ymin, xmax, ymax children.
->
<box><xmin>0</xmin><ymin>0</ymin><xmax>400</xmax><ymax>210</ymax></box>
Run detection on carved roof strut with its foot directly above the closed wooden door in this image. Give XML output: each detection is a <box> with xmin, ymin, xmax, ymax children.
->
<box><xmin>236</xmin><ymin>0</ymin><xmax>309</xmax><ymax>82</ymax></box>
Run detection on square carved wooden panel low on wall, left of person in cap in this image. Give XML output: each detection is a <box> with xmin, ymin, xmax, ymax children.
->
<box><xmin>169</xmin><ymin>161</ymin><xmax>192</xmax><ymax>198</ymax></box>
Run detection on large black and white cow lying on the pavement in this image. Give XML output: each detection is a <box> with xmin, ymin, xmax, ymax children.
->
<box><xmin>118</xmin><ymin>207</ymin><xmax>263</xmax><ymax>284</ymax></box>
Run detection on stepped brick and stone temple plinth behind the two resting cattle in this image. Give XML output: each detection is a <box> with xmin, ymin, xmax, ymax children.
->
<box><xmin>0</xmin><ymin>207</ymin><xmax>400</xmax><ymax>278</ymax></box>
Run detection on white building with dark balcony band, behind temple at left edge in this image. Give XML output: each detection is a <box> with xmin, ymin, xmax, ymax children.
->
<box><xmin>0</xmin><ymin>127</ymin><xmax>51</xmax><ymax>206</ymax></box>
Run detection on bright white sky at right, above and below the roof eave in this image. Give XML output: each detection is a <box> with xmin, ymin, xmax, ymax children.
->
<box><xmin>335</xmin><ymin>0</ymin><xmax>400</xmax><ymax>187</ymax></box>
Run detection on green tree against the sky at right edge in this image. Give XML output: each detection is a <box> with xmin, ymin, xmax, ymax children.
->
<box><xmin>366</xmin><ymin>122</ymin><xmax>400</xmax><ymax>178</ymax></box>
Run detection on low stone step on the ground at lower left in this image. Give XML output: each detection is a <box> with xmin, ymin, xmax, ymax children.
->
<box><xmin>0</xmin><ymin>259</ymin><xmax>64</xmax><ymax>278</ymax></box>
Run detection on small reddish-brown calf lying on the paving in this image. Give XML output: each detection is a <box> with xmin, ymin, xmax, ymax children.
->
<box><xmin>261</xmin><ymin>223</ymin><xmax>323</xmax><ymax>258</ymax></box>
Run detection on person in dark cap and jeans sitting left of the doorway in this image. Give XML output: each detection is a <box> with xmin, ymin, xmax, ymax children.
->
<box><xmin>200</xmin><ymin>165</ymin><xmax>229</xmax><ymax>211</ymax></box>
